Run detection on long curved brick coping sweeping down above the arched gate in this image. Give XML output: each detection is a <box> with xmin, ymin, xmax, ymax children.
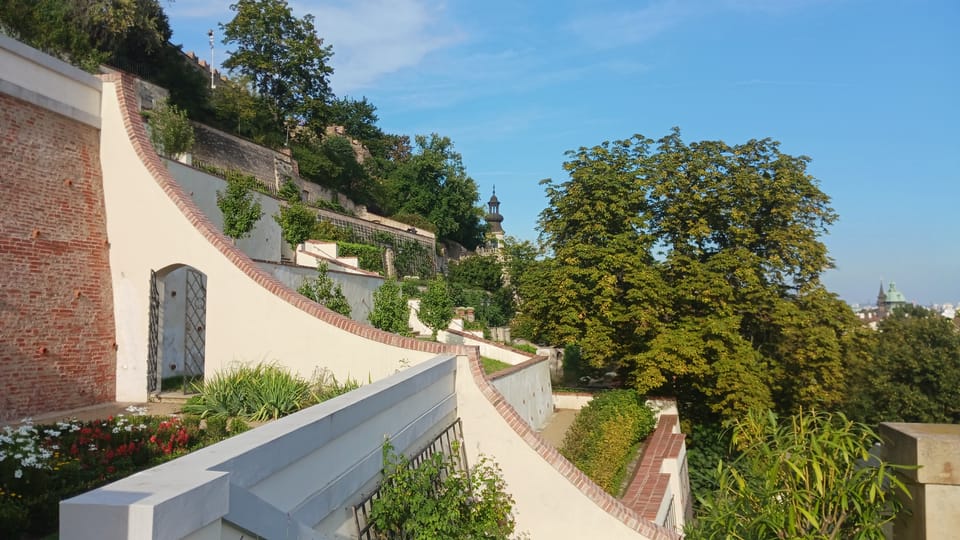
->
<box><xmin>100</xmin><ymin>72</ymin><xmax>469</xmax><ymax>354</ymax></box>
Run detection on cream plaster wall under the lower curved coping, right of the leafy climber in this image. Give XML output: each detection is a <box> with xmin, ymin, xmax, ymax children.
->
<box><xmin>457</xmin><ymin>357</ymin><xmax>660</xmax><ymax>540</ymax></box>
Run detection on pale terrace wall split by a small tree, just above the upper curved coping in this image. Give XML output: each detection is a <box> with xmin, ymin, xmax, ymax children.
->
<box><xmin>163</xmin><ymin>159</ymin><xmax>283</xmax><ymax>262</ymax></box>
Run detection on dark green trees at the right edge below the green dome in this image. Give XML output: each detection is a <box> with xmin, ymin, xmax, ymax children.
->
<box><xmin>845</xmin><ymin>306</ymin><xmax>960</xmax><ymax>425</ymax></box>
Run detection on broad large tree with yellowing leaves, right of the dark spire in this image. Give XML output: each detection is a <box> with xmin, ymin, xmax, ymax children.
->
<box><xmin>518</xmin><ymin>130</ymin><xmax>855</xmax><ymax>418</ymax></box>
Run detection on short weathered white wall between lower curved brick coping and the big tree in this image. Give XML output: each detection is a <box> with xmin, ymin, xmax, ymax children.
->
<box><xmin>490</xmin><ymin>358</ymin><xmax>553</xmax><ymax>431</ymax></box>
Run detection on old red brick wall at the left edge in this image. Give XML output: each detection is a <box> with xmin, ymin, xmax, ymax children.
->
<box><xmin>0</xmin><ymin>94</ymin><xmax>116</xmax><ymax>421</ymax></box>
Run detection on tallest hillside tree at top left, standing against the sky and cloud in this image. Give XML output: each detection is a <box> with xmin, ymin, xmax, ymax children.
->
<box><xmin>221</xmin><ymin>0</ymin><xmax>333</xmax><ymax>123</ymax></box>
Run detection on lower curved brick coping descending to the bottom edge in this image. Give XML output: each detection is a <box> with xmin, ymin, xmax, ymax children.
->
<box><xmin>468</xmin><ymin>354</ymin><xmax>683</xmax><ymax>540</ymax></box>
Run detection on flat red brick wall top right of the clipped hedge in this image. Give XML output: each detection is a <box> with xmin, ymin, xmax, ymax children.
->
<box><xmin>621</xmin><ymin>414</ymin><xmax>685</xmax><ymax>520</ymax></box>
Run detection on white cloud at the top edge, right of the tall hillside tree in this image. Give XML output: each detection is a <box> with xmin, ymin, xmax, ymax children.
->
<box><xmin>293</xmin><ymin>0</ymin><xmax>464</xmax><ymax>94</ymax></box>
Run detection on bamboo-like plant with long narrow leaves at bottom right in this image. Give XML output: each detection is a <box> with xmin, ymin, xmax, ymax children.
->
<box><xmin>687</xmin><ymin>412</ymin><xmax>909</xmax><ymax>540</ymax></box>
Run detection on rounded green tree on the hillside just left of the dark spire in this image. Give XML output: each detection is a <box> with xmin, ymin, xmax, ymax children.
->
<box><xmin>383</xmin><ymin>134</ymin><xmax>484</xmax><ymax>249</ymax></box>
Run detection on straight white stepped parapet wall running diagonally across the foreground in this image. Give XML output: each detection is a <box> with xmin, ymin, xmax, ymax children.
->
<box><xmin>60</xmin><ymin>356</ymin><xmax>457</xmax><ymax>540</ymax></box>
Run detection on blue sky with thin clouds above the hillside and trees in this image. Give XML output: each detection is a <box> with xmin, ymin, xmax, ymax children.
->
<box><xmin>167</xmin><ymin>0</ymin><xmax>960</xmax><ymax>304</ymax></box>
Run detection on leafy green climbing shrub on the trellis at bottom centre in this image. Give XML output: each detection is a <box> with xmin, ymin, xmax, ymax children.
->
<box><xmin>370</xmin><ymin>441</ymin><xmax>515</xmax><ymax>540</ymax></box>
